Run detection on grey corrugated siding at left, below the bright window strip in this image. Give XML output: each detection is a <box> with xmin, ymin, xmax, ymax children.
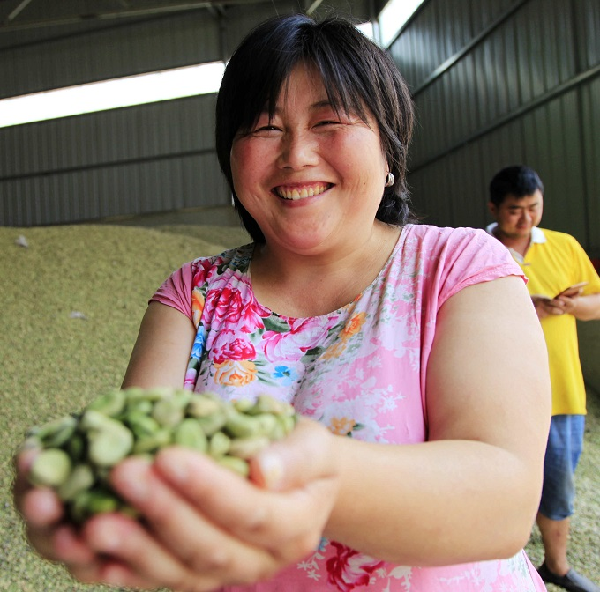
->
<box><xmin>0</xmin><ymin>95</ymin><xmax>230</xmax><ymax>226</ymax></box>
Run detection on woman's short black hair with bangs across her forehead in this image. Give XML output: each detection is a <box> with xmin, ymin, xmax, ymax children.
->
<box><xmin>215</xmin><ymin>14</ymin><xmax>414</xmax><ymax>243</ymax></box>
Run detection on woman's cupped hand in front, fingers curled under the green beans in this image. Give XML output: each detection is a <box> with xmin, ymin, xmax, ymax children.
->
<box><xmin>70</xmin><ymin>419</ymin><xmax>340</xmax><ymax>592</ymax></box>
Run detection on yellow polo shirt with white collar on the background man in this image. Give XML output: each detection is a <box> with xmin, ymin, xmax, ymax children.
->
<box><xmin>513</xmin><ymin>228</ymin><xmax>600</xmax><ymax>415</ymax></box>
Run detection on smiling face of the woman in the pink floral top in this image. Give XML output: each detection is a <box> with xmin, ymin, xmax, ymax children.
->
<box><xmin>231</xmin><ymin>65</ymin><xmax>388</xmax><ymax>254</ymax></box>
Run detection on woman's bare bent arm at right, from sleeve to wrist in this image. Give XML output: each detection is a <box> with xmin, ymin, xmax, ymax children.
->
<box><xmin>326</xmin><ymin>278</ymin><xmax>550</xmax><ymax>565</ymax></box>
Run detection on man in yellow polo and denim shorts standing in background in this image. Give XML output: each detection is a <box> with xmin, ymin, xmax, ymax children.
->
<box><xmin>486</xmin><ymin>166</ymin><xmax>600</xmax><ymax>592</ymax></box>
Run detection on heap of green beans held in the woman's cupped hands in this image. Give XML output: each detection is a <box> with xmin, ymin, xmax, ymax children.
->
<box><xmin>24</xmin><ymin>388</ymin><xmax>296</xmax><ymax>524</ymax></box>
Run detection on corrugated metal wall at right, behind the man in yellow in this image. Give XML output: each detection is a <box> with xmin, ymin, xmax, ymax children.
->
<box><xmin>390</xmin><ymin>0</ymin><xmax>600</xmax><ymax>257</ymax></box>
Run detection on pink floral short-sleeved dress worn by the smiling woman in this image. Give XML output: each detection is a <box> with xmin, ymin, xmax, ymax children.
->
<box><xmin>153</xmin><ymin>226</ymin><xmax>546</xmax><ymax>592</ymax></box>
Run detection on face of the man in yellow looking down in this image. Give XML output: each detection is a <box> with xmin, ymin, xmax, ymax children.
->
<box><xmin>490</xmin><ymin>189</ymin><xmax>544</xmax><ymax>239</ymax></box>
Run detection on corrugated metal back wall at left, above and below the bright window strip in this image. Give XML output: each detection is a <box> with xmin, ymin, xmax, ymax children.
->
<box><xmin>0</xmin><ymin>11</ymin><xmax>230</xmax><ymax>226</ymax></box>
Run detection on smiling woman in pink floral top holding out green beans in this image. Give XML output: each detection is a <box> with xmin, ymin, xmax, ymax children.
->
<box><xmin>17</xmin><ymin>15</ymin><xmax>550</xmax><ymax>592</ymax></box>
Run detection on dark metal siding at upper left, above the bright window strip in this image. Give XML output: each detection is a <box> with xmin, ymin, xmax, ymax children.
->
<box><xmin>0</xmin><ymin>10</ymin><xmax>223</xmax><ymax>98</ymax></box>
